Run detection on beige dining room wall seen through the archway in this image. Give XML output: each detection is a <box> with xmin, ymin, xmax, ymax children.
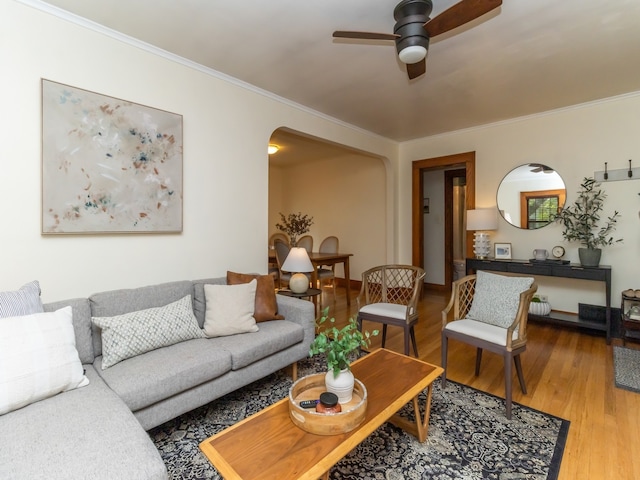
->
<box><xmin>269</xmin><ymin>152</ymin><xmax>389</xmax><ymax>280</ymax></box>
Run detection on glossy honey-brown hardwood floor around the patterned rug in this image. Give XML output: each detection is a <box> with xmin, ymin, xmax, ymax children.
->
<box><xmin>314</xmin><ymin>288</ymin><xmax>640</xmax><ymax>480</ymax></box>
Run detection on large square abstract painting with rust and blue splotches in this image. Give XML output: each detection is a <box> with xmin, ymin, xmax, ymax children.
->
<box><xmin>42</xmin><ymin>79</ymin><xmax>182</xmax><ymax>234</ymax></box>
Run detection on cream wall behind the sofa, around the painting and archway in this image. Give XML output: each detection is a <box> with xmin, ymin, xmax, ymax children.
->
<box><xmin>0</xmin><ymin>0</ymin><xmax>397</xmax><ymax>301</ymax></box>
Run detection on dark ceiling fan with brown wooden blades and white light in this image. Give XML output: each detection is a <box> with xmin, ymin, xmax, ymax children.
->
<box><xmin>333</xmin><ymin>0</ymin><xmax>502</xmax><ymax>79</ymax></box>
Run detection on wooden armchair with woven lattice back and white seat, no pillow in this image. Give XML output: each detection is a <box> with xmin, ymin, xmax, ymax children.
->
<box><xmin>357</xmin><ymin>265</ymin><xmax>425</xmax><ymax>357</ymax></box>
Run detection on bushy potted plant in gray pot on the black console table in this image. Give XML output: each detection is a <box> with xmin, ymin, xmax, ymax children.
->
<box><xmin>553</xmin><ymin>177</ymin><xmax>622</xmax><ymax>267</ymax></box>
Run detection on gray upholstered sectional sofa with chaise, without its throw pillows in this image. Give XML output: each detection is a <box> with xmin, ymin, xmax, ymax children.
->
<box><xmin>0</xmin><ymin>278</ymin><xmax>315</xmax><ymax>480</ymax></box>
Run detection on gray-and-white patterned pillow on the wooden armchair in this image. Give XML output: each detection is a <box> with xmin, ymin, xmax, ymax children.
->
<box><xmin>466</xmin><ymin>270</ymin><xmax>533</xmax><ymax>328</ymax></box>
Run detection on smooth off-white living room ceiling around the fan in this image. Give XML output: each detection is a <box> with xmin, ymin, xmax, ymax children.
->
<box><xmin>42</xmin><ymin>0</ymin><xmax>640</xmax><ymax>141</ymax></box>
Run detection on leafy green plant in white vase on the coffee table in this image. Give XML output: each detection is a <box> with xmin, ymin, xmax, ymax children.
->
<box><xmin>309</xmin><ymin>307</ymin><xmax>379</xmax><ymax>403</ymax></box>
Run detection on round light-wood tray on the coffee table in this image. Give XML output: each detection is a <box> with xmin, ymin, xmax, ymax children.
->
<box><xmin>289</xmin><ymin>373</ymin><xmax>367</xmax><ymax>435</ymax></box>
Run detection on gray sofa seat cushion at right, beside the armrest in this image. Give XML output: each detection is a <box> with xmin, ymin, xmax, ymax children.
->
<box><xmin>212</xmin><ymin>320</ymin><xmax>308</xmax><ymax>370</ymax></box>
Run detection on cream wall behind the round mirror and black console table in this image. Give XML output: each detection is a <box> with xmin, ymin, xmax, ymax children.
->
<box><xmin>397</xmin><ymin>93</ymin><xmax>640</xmax><ymax>312</ymax></box>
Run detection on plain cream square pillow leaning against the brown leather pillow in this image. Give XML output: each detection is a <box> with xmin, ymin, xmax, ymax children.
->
<box><xmin>204</xmin><ymin>279</ymin><xmax>258</xmax><ymax>337</ymax></box>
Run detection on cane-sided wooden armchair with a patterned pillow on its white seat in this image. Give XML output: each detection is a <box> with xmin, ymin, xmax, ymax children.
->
<box><xmin>441</xmin><ymin>270</ymin><xmax>538</xmax><ymax>419</ymax></box>
